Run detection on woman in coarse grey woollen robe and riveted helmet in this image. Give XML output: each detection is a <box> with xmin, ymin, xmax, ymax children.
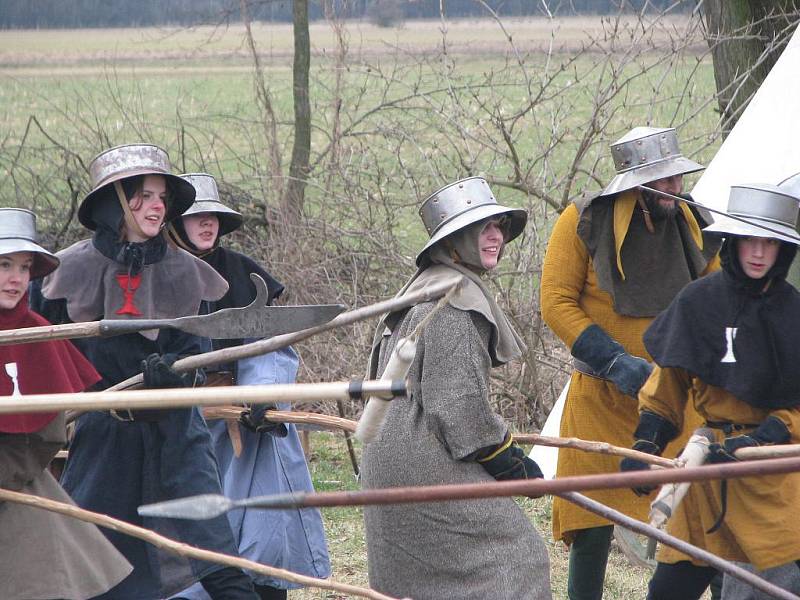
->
<box><xmin>362</xmin><ymin>177</ymin><xmax>551</xmax><ymax>600</ymax></box>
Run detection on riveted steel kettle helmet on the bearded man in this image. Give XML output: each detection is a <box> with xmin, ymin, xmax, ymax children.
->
<box><xmin>601</xmin><ymin>127</ymin><xmax>705</xmax><ymax>196</ymax></box>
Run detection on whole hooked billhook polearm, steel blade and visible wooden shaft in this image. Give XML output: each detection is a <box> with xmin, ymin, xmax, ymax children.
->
<box><xmin>0</xmin><ymin>273</ymin><xmax>345</xmax><ymax>346</ymax></box>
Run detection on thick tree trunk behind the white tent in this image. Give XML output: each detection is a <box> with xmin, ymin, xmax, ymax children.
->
<box><xmin>702</xmin><ymin>0</ymin><xmax>798</xmax><ymax>133</ymax></box>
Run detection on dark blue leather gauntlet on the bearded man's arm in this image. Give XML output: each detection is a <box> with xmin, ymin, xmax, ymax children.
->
<box><xmin>571</xmin><ymin>324</ymin><xmax>653</xmax><ymax>398</ymax></box>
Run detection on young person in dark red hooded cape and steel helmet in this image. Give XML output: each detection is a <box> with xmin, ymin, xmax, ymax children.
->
<box><xmin>0</xmin><ymin>208</ymin><xmax>132</xmax><ymax>600</ymax></box>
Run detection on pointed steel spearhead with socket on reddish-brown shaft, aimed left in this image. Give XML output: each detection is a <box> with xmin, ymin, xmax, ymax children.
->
<box><xmin>137</xmin><ymin>492</ymin><xmax>305</xmax><ymax>521</ymax></box>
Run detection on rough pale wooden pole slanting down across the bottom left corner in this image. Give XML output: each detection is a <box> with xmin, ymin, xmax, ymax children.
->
<box><xmin>0</xmin><ymin>488</ymin><xmax>396</xmax><ymax>600</ymax></box>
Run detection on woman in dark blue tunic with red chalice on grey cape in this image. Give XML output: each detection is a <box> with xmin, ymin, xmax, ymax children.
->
<box><xmin>28</xmin><ymin>144</ymin><xmax>256</xmax><ymax>600</ymax></box>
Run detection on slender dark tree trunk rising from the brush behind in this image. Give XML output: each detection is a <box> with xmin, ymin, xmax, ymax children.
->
<box><xmin>283</xmin><ymin>0</ymin><xmax>311</xmax><ymax>223</ymax></box>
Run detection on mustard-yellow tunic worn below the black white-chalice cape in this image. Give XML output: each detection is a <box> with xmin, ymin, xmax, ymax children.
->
<box><xmin>639</xmin><ymin>367</ymin><xmax>800</xmax><ymax>570</ymax></box>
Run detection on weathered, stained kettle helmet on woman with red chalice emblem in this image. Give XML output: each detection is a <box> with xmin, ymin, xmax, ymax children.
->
<box><xmin>78</xmin><ymin>144</ymin><xmax>195</xmax><ymax>230</ymax></box>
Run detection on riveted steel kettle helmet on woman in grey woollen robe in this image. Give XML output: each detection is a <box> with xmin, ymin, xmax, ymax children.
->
<box><xmin>417</xmin><ymin>177</ymin><xmax>528</xmax><ymax>266</ymax></box>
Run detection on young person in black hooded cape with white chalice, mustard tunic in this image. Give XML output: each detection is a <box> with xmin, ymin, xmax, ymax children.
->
<box><xmin>622</xmin><ymin>184</ymin><xmax>800</xmax><ymax>600</ymax></box>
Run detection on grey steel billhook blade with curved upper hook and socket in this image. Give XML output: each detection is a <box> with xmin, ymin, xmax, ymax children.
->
<box><xmin>100</xmin><ymin>273</ymin><xmax>345</xmax><ymax>340</ymax></box>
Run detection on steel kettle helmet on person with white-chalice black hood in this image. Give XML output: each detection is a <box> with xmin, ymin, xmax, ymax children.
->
<box><xmin>704</xmin><ymin>183</ymin><xmax>800</xmax><ymax>246</ymax></box>
